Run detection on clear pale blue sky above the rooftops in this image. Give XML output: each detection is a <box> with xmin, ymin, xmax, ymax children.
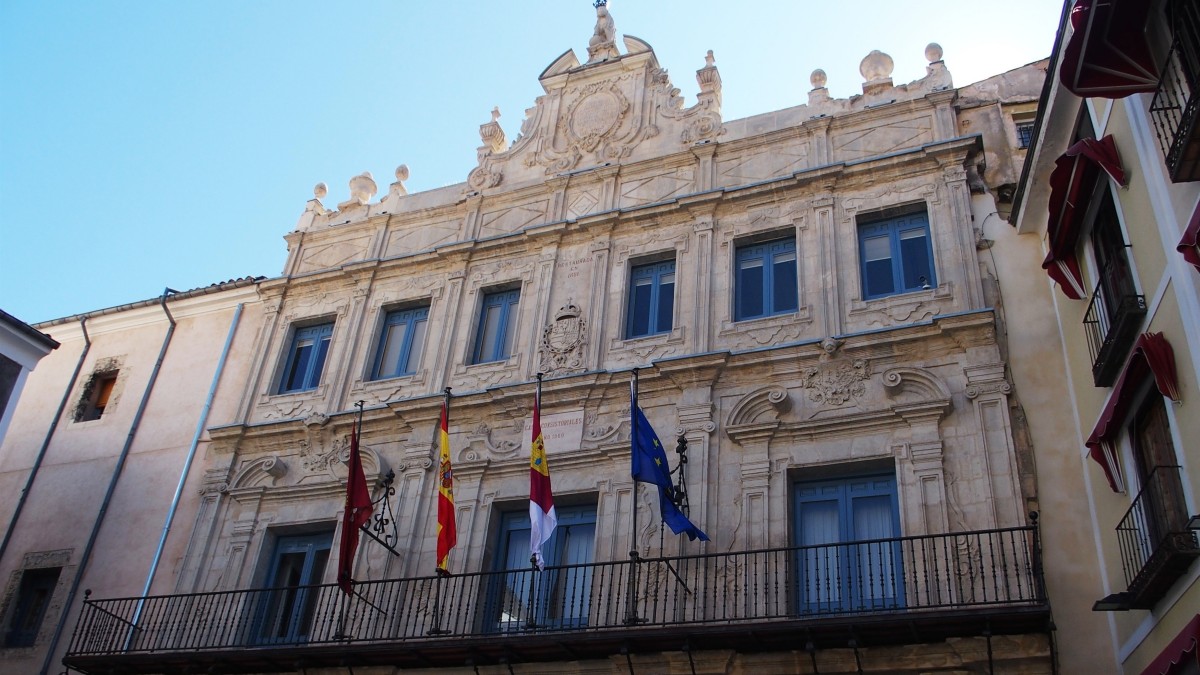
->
<box><xmin>0</xmin><ymin>0</ymin><xmax>1062</xmax><ymax>323</ymax></box>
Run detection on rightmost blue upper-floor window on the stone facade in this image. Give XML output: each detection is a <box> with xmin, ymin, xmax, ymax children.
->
<box><xmin>858</xmin><ymin>213</ymin><xmax>937</xmax><ymax>299</ymax></box>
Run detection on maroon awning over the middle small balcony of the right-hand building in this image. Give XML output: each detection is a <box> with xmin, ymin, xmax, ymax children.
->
<box><xmin>1042</xmin><ymin>136</ymin><xmax>1126</xmax><ymax>300</ymax></box>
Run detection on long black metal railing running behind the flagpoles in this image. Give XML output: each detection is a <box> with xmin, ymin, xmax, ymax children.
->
<box><xmin>67</xmin><ymin>526</ymin><xmax>1045</xmax><ymax>662</ymax></box>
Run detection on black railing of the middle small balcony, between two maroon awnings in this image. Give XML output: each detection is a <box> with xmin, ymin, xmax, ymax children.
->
<box><xmin>1084</xmin><ymin>265</ymin><xmax>1146</xmax><ymax>387</ymax></box>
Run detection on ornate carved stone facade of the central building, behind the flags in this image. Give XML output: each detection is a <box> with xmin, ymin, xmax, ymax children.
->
<box><xmin>4</xmin><ymin>2</ymin><xmax>1080</xmax><ymax>673</ymax></box>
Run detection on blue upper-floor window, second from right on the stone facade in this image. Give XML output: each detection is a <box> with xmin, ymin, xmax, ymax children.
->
<box><xmin>733</xmin><ymin>239</ymin><xmax>799</xmax><ymax>321</ymax></box>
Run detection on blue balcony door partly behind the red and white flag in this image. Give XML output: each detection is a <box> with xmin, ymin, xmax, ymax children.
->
<box><xmin>486</xmin><ymin>504</ymin><xmax>596</xmax><ymax>632</ymax></box>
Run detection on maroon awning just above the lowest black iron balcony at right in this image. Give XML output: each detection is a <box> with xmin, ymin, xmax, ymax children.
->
<box><xmin>1085</xmin><ymin>333</ymin><xmax>1180</xmax><ymax>492</ymax></box>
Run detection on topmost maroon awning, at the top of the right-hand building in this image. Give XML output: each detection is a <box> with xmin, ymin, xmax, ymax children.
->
<box><xmin>1058</xmin><ymin>0</ymin><xmax>1158</xmax><ymax>98</ymax></box>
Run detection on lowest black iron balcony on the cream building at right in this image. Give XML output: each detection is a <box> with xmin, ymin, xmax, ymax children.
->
<box><xmin>1117</xmin><ymin>466</ymin><xmax>1200</xmax><ymax>609</ymax></box>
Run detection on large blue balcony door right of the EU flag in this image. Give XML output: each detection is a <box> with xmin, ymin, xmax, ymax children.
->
<box><xmin>794</xmin><ymin>474</ymin><xmax>904</xmax><ymax>613</ymax></box>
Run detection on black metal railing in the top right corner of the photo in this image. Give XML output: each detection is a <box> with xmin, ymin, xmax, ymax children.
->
<box><xmin>1150</xmin><ymin>0</ymin><xmax>1200</xmax><ymax>183</ymax></box>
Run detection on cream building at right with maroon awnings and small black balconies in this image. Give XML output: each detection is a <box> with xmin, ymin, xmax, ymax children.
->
<box><xmin>1012</xmin><ymin>1</ymin><xmax>1200</xmax><ymax>675</ymax></box>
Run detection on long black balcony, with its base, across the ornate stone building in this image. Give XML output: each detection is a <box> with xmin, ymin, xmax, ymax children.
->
<box><xmin>64</xmin><ymin>526</ymin><xmax>1050</xmax><ymax>674</ymax></box>
